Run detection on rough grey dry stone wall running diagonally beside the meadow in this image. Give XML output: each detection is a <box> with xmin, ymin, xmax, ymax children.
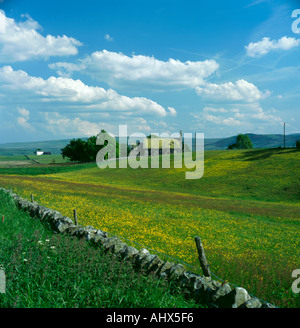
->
<box><xmin>0</xmin><ymin>188</ymin><xmax>274</xmax><ymax>308</ymax></box>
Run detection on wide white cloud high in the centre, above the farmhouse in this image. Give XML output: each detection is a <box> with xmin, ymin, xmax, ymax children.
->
<box><xmin>49</xmin><ymin>50</ymin><xmax>219</xmax><ymax>88</ymax></box>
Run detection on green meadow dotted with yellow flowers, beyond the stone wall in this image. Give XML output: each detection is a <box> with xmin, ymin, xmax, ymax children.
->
<box><xmin>0</xmin><ymin>149</ymin><xmax>300</xmax><ymax>307</ymax></box>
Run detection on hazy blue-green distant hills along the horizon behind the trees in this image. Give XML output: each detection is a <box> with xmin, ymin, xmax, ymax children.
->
<box><xmin>0</xmin><ymin>133</ymin><xmax>300</xmax><ymax>156</ymax></box>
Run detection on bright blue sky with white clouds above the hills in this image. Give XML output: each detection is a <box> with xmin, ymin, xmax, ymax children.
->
<box><xmin>0</xmin><ymin>0</ymin><xmax>300</xmax><ymax>143</ymax></box>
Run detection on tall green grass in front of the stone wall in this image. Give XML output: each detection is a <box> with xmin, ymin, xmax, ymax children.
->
<box><xmin>0</xmin><ymin>191</ymin><xmax>198</xmax><ymax>308</ymax></box>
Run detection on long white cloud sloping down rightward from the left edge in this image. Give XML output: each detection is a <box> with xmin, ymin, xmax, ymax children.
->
<box><xmin>0</xmin><ymin>66</ymin><xmax>174</xmax><ymax>116</ymax></box>
